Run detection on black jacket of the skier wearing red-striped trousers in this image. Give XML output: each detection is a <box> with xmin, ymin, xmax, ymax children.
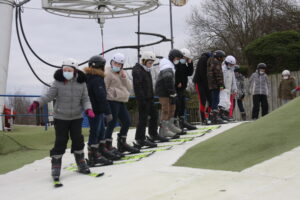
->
<box><xmin>193</xmin><ymin>52</ymin><xmax>211</xmax><ymax>88</ymax></box>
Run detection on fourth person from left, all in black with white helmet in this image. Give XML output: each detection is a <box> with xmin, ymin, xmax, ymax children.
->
<box><xmin>132</xmin><ymin>51</ymin><xmax>168</xmax><ymax>148</ymax></box>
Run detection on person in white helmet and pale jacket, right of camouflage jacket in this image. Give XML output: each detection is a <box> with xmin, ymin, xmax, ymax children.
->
<box><xmin>218</xmin><ymin>56</ymin><xmax>237</xmax><ymax>121</ymax></box>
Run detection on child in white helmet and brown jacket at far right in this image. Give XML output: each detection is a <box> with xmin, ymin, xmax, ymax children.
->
<box><xmin>278</xmin><ymin>70</ymin><xmax>296</xmax><ymax>104</ymax></box>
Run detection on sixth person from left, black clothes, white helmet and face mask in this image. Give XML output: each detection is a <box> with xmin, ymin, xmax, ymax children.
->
<box><xmin>175</xmin><ymin>48</ymin><xmax>197</xmax><ymax>130</ymax></box>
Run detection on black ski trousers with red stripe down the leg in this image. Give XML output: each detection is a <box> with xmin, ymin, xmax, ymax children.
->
<box><xmin>195</xmin><ymin>83</ymin><xmax>211</xmax><ymax>122</ymax></box>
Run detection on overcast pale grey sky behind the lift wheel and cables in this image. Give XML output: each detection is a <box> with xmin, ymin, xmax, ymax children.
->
<box><xmin>6</xmin><ymin>0</ymin><xmax>200</xmax><ymax>95</ymax></box>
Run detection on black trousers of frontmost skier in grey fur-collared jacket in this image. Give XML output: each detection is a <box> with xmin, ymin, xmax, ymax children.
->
<box><xmin>50</xmin><ymin>118</ymin><xmax>84</xmax><ymax>156</ymax></box>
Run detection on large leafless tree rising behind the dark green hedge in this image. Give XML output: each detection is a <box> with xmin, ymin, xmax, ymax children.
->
<box><xmin>187</xmin><ymin>0</ymin><xmax>300</xmax><ymax>63</ymax></box>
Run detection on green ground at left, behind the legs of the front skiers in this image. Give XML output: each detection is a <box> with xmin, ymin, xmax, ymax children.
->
<box><xmin>0</xmin><ymin>126</ymin><xmax>124</xmax><ymax>174</ymax></box>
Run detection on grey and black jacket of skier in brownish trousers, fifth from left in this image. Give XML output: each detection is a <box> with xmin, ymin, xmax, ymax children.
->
<box><xmin>155</xmin><ymin>68</ymin><xmax>176</xmax><ymax>97</ymax></box>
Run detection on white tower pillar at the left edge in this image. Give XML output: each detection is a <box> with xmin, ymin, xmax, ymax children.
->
<box><xmin>0</xmin><ymin>0</ymin><xmax>14</xmax><ymax>131</ymax></box>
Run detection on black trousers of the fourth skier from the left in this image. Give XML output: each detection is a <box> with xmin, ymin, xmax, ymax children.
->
<box><xmin>135</xmin><ymin>99</ymin><xmax>158</xmax><ymax>140</ymax></box>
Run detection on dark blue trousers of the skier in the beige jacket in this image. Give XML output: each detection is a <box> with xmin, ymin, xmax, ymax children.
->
<box><xmin>105</xmin><ymin>101</ymin><xmax>131</xmax><ymax>139</ymax></box>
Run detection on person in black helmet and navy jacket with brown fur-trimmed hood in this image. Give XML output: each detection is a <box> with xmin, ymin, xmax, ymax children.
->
<box><xmin>84</xmin><ymin>55</ymin><xmax>121</xmax><ymax>166</ymax></box>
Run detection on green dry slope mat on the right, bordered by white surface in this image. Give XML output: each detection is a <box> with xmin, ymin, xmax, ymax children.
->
<box><xmin>175</xmin><ymin>97</ymin><xmax>300</xmax><ymax>171</ymax></box>
